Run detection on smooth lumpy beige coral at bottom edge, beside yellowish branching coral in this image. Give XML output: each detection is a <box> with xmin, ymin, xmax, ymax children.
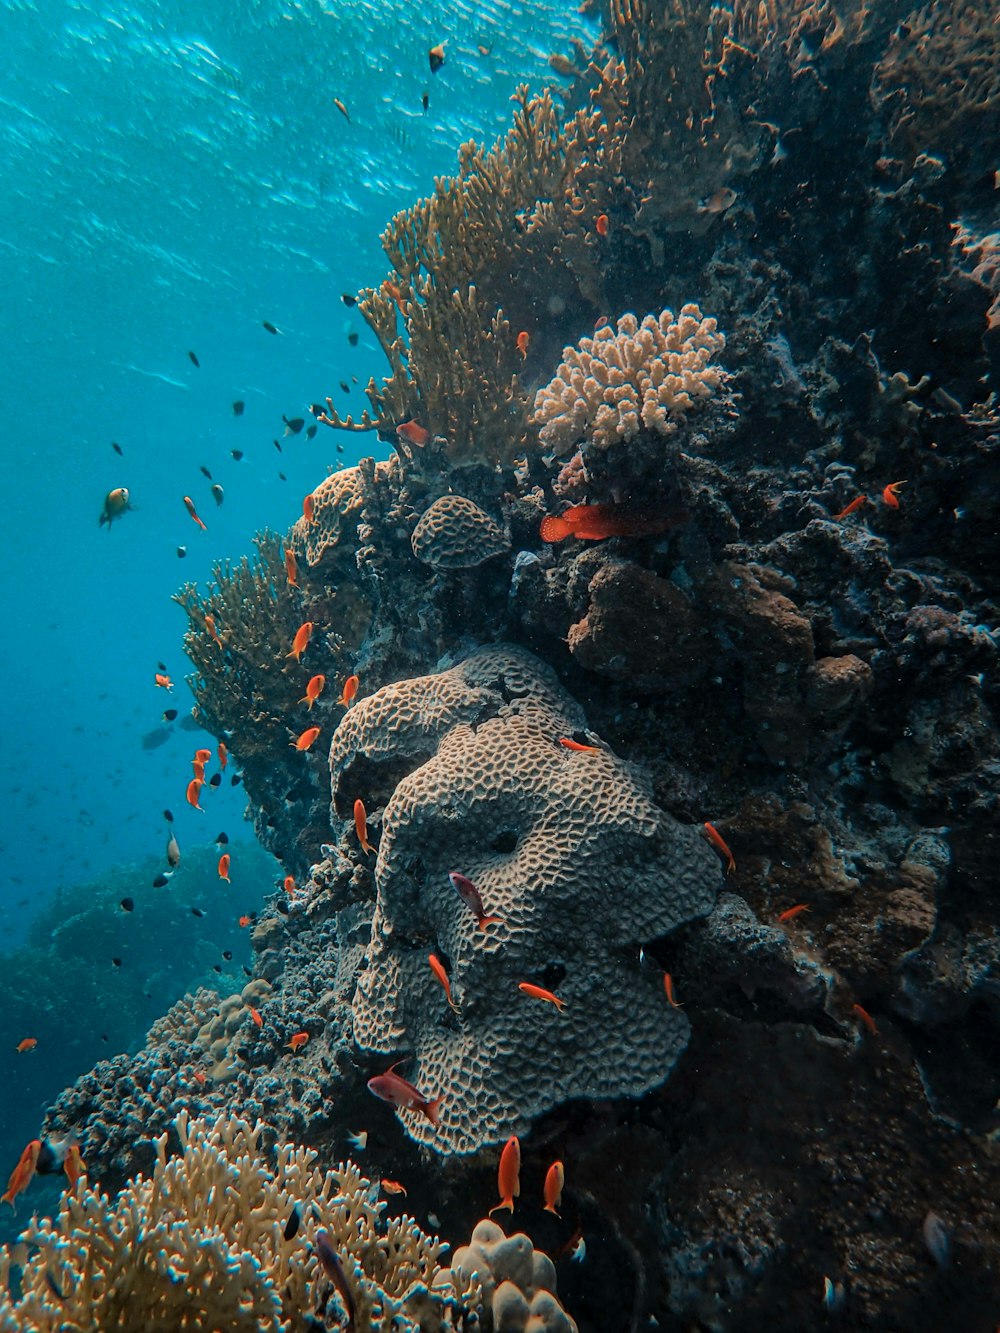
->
<box><xmin>452</xmin><ymin>1218</ymin><xmax>577</xmax><ymax>1333</ymax></box>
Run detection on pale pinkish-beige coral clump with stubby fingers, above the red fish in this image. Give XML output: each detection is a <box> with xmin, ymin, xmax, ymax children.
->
<box><xmin>533</xmin><ymin>305</ymin><xmax>725</xmax><ymax>453</ymax></box>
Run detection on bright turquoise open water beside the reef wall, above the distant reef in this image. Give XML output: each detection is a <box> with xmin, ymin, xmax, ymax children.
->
<box><xmin>0</xmin><ymin>0</ymin><xmax>593</xmax><ymax>948</ymax></box>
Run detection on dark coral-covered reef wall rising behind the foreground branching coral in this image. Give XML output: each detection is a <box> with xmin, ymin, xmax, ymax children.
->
<box><xmin>35</xmin><ymin>0</ymin><xmax>1000</xmax><ymax>1333</ymax></box>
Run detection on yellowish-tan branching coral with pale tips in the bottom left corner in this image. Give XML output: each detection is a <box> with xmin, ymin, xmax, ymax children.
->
<box><xmin>0</xmin><ymin>1113</ymin><xmax>480</xmax><ymax>1333</ymax></box>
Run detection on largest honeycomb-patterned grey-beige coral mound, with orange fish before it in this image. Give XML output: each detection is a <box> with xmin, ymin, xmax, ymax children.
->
<box><xmin>331</xmin><ymin>644</ymin><xmax>719</xmax><ymax>1153</ymax></box>
